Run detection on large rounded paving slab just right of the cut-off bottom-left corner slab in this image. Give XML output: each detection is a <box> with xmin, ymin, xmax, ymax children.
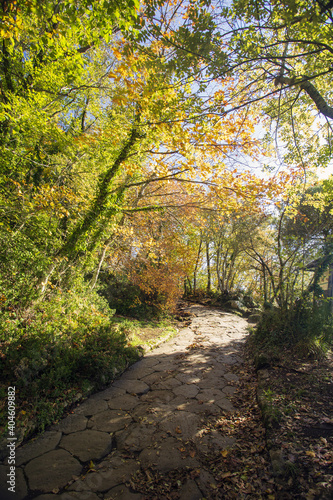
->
<box><xmin>24</xmin><ymin>450</ymin><xmax>82</xmax><ymax>493</ymax></box>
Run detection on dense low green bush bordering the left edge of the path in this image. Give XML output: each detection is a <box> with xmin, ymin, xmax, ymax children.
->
<box><xmin>0</xmin><ymin>282</ymin><xmax>140</xmax><ymax>438</ymax></box>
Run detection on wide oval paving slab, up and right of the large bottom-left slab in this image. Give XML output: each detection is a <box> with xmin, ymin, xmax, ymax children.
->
<box><xmin>59</xmin><ymin>429</ymin><xmax>112</xmax><ymax>462</ymax></box>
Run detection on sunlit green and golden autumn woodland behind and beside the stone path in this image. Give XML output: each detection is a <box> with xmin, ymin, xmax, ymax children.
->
<box><xmin>0</xmin><ymin>0</ymin><xmax>333</xmax><ymax>488</ymax></box>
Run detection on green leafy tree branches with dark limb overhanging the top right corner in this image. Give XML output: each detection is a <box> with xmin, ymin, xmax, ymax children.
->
<box><xmin>141</xmin><ymin>0</ymin><xmax>333</xmax><ymax>173</ymax></box>
